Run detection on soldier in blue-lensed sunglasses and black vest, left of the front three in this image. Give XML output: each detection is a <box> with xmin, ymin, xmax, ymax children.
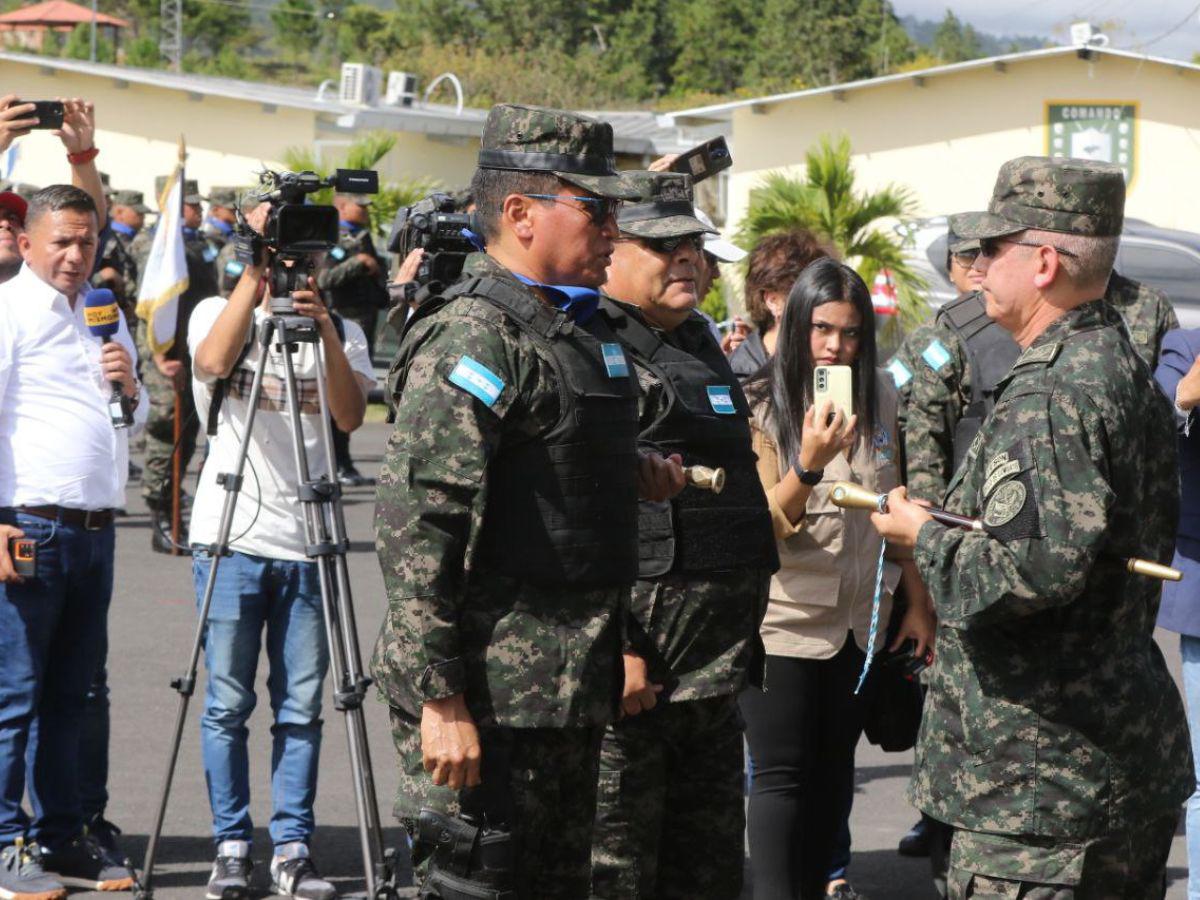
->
<box><xmin>371</xmin><ymin>106</ymin><xmax>683</xmax><ymax>900</ymax></box>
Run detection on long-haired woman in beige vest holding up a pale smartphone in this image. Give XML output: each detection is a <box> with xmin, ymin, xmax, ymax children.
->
<box><xmin>740</xmin><ymin>258</ymin><xmax>935</xmax><ymax>900</ymax></box>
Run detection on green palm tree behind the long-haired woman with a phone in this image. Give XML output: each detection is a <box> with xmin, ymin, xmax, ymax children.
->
<box><xmin>737</xmin><ymin>137</ymin><xmax>929</xmax><ymax>324</ymax></box>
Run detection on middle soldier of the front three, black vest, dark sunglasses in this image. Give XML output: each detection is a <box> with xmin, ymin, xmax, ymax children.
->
<box><xmin>592</xmin><ymin>172</ymin><xmax>779</xmax><ymax>900</ymax></box>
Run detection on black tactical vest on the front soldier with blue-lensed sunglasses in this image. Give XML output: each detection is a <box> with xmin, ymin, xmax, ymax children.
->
<box><xmin>397</xmin><ymin>276</ymin><xmax>638</xmax><ymax>588</ymax></box>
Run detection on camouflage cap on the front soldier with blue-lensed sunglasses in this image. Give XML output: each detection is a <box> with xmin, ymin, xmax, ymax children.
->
<box><xmin>479</xmin><ymin>103</ymin><xmax>636</xmax><ymax>200</ymax></box>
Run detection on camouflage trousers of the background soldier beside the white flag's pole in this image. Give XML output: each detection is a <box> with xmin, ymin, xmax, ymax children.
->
<box><xmin>138</xmin><ymin>328</ymin><xmax>200</xmax><ymax>512</ymax></box>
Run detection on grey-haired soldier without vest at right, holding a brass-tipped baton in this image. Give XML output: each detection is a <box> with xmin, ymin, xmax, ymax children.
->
<box><xmin>872</xmin><ymin>157</ymin><xmax>1195</xmax><ymax>900</ymax></box>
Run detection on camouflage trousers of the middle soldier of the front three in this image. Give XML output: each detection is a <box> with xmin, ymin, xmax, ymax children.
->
<box><xmin>592</xmin><ymin>696</ymin><xmax>745</xmax><ymax>900</ymax></box>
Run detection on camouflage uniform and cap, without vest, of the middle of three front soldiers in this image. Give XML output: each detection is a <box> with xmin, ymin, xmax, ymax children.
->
<box><xmin>592</xmin><ymin>173</ymin><xmax>778</xmax><ymax>900</ymax></box>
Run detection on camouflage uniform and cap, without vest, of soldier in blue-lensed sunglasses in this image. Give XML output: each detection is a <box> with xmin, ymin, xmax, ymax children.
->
<box><xmin>371</xmin><ymin>106</ymin><xmax>636</xmax><ymax>898</ymax></box>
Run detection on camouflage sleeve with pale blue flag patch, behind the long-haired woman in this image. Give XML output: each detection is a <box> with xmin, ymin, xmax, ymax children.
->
<box><xmin>904</xmin><ymin>323</ymin><xmax>970</xmax><ymax>503</ymax></box>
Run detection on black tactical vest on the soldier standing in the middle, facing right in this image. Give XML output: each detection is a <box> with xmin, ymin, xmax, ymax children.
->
<box><xmin>601</xmin><ymin>299</ymin><xmax>779</xmax><ymax>578</ymax></box>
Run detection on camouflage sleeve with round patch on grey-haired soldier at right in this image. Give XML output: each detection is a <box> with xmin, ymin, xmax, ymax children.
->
<box><xmin>916</xmin><ymin>384</ymin><xmax>1115</xmax><ymax>629</ymax></box>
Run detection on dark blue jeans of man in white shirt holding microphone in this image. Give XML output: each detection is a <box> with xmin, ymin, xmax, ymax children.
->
<box><xmin>0</xmin><ymin>510</ymin><xmax>113</xmax><ymax>850</ymax></box>
